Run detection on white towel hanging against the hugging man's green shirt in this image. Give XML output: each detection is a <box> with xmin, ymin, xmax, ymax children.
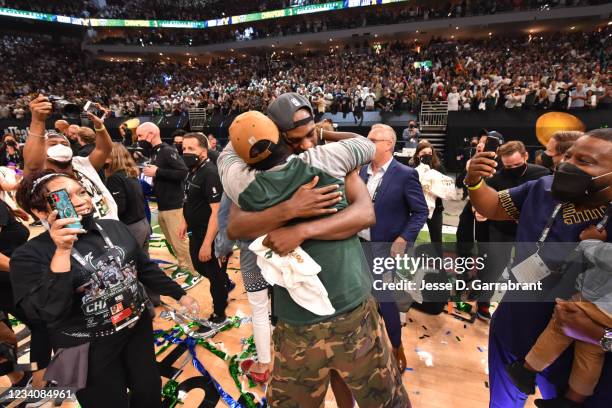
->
<box><xmin>249</xmin><ymin>235</ymin><xmax>336</xmax><ymax>316</ymax></box>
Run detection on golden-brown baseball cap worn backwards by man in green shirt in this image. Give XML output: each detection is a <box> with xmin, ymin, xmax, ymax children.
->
<box><xmin>229</xmin><ymin>111</ymin><xmax>280</xmax><ymax>164</ymax></box>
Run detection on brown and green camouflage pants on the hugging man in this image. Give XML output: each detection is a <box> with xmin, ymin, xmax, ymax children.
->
<box><xmin>267</xmin><ymin>298</ymin><xmax>410</xmax><ymax>408</ymax></box>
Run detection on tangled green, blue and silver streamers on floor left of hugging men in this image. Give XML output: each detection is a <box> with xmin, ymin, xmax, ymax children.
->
<box><xmin>153</xmin><ymin>303</ymin><xmax>267</xmax><ymax>408</ymax></box>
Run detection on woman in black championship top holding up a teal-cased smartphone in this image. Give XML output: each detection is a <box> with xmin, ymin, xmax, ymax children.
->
<box><xmin>10</xmin><ymin>170</ymin><xmax>199</xmax><ymax>408</ymax></box>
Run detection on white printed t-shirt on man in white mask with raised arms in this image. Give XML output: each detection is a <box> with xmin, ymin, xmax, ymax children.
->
<box><xmin>72</xmin><ymin>157</ymin><xmax>119</xmax><ymax>220</ymax></box>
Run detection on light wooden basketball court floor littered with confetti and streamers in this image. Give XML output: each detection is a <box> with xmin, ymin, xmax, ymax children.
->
<box><xmin>0</xmin><ymin>225</ymin><xmax>532</xmax><ymax>408</ymax></box>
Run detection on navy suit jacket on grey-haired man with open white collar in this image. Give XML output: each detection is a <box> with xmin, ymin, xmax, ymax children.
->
<box><xmin>359</xmin><ymin>159</ymin><xmax>429</xmax><ymax>244</ymax></box>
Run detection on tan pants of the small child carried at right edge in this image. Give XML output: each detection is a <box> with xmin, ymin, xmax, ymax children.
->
<box><xmin>525</xmin><ymin>302</ymin><xmax>612</xmax><ymax>396</ymax></box>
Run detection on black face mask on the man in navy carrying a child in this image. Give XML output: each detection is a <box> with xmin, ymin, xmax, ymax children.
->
<box><xmin>550</xmin><ymin>162</ymin><xmax>612</xmax><ymax>204</ymax></box>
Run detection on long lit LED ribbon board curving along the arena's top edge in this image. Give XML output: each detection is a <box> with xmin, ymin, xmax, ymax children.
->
<box><xmin>0</xmin><ymin>0</ymin><xmax>409</xmax><ymax>29</ymax></box>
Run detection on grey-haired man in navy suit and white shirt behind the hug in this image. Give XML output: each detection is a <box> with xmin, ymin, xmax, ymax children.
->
<box><xmin>358</xmin><ymin>124</ymin><xmax>429</xmax><ymax>372</ymax></box>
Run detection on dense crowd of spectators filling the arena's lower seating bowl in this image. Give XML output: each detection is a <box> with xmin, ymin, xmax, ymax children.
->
<box><xmin>0</xmin><ymin>27</ymin><xmax>612</xmax><ymax>120</ymax></box>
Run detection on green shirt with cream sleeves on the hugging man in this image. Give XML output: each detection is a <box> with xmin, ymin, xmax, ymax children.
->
<box><xmin>217</xmin><ymin>137</ymin><xmax>375</xmax><ymax>325</ymax></box>
